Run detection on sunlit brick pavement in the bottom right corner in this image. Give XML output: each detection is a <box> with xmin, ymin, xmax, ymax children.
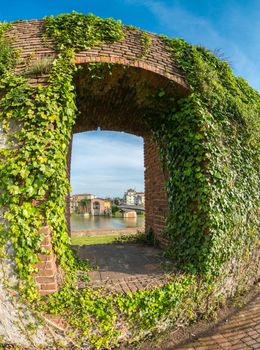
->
<box><xmin>172</xmin><ymin>293</ymin><xmax>260</xmax><ymax>350</ymax></box>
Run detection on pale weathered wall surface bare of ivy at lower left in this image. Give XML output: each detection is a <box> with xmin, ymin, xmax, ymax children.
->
<box><xmin>0</xmin><ymin>125</ymin><xmax>61</xmax><ymax>348</ymax></box>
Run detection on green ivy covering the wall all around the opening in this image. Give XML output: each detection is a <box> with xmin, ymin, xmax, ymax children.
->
<box><xmin>0</xmin><ymin>13</ymin><xmax>260</xmax><ymax>349</ymax></box>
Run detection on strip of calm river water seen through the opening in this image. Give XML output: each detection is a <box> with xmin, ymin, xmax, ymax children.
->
<box><xmin>71</xmin><ymin>214</ymin><xmax>144</xmax><ymax>231</ymax></box>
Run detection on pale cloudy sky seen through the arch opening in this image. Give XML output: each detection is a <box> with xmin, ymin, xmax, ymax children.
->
<box><xmin>71</xmin><ymin>132</ymin><xmax>144</xmax><ymax>197</ymax></box>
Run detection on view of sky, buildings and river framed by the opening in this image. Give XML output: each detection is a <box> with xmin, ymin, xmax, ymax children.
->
<box><xmin>70</xmin><ymin>131</ymin><xmax>145</xmax><ymax>235</ymax></box>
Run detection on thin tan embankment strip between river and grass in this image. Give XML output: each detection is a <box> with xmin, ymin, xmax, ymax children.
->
<box><xmin>71</xmin><ymin>227</ymin><xmax>144</xmax><ymax>237</ymax></box>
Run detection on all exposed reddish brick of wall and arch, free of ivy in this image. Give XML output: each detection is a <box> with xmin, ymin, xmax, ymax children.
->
<box><xmin>6</xmin><ymin>20</ymin><xmax>189</xmax><ymax>295</ymax></box>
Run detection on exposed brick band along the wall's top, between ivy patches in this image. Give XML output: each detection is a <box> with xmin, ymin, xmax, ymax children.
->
<box><xmin>6</xmin><ymin>20</ymin><xmax>189</xmax><ymax>94</ymax></box>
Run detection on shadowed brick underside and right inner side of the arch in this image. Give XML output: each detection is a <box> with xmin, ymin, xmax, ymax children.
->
<box><xmin>67</xmin><ymin>63</ymin><xmax>182</xmax><ymax>247</ymax></box>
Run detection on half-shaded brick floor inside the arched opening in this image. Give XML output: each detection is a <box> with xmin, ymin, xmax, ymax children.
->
<box><xmin>78</xmin><ymin>243</ymin><xmax>171</xmax><ymax>292</ymax></box>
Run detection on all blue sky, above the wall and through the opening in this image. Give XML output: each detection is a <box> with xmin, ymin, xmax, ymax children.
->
<box><xmin>0</xmin><ymin>0</ymin><xmax>260</xmax><ymax>196</ymax></box>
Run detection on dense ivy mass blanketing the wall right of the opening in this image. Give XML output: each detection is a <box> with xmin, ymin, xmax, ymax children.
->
<box><xmin>157</xmin><ymin>39</ymin><xmax>260</xmax><ymax>274</ymax></box>
